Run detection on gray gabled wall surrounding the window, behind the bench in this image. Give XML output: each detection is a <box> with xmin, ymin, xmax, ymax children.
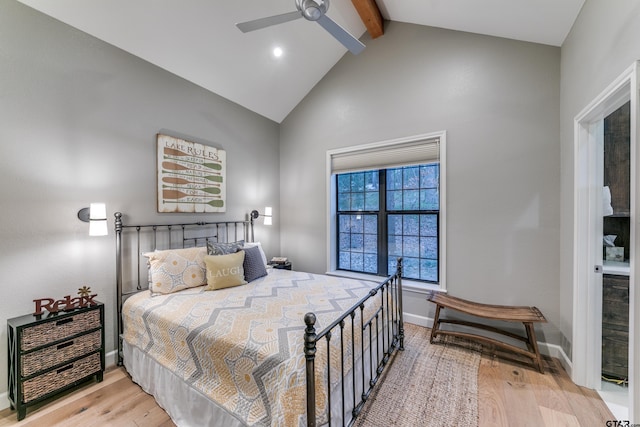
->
<box><xmin>280</xmin><ymin>22</ymin><xmax>560</xmax><ymax>343</ymax></box>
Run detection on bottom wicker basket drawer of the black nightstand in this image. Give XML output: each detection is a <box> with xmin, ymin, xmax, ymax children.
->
<box><xmin>22</xmin><ymin>353</ymin><xmax>102</xmax><ymax>403</ymax></box>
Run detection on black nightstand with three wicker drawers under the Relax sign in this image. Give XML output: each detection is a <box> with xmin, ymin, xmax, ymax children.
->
<box><xmin>7</xmin><ymin>303</ymin><xmax>105</xmax><ymax>421</ymax></box>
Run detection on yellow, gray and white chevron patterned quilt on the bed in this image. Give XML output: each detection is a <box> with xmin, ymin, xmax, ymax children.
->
<box><xmin>123</xmin><ymin>269</ymin><xmax>379</xmax><ymax>426</ymax></box>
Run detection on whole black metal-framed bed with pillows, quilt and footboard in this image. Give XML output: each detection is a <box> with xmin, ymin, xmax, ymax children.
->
<box><xmin>115</xmin><ymin>213</ymin><xmax>404</xmax><ymax>426</ymax></box>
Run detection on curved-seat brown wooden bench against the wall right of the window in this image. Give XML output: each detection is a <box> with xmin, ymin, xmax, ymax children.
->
<box><xmin>427</xmin><ymin>292</ymin><xmax>547</xmax><ymax>373</ymax></box>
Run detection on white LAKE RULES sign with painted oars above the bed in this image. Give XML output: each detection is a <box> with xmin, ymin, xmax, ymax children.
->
<box><xmin>157</xmin><ymin>134</ymin><xmax>226</xmax><ymax>213</ymax></box>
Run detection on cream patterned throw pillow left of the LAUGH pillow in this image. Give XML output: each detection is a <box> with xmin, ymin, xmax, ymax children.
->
<box><xmin>144</xmin><ymin>246</ymin><xmax>207</xmax><ymax>295</ymax></box>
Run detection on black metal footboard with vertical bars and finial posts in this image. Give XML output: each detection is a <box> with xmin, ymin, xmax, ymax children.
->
<box><xmin>304</xmin><ymin>258</ymin><xmax>404</xmax><ymax>427</ymax></box>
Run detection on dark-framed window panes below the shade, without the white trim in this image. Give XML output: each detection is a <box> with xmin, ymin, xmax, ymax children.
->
<box><xmin>335</xmin><ymin>163</ymin><xmax>440</xmax><ymax>283</ymax></box>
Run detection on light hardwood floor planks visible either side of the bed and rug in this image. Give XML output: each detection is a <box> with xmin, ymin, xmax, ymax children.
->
<box><xmin>0</xmin><ymin>353</ymin><xmax>614</xmax><ymax>427</ymax></box>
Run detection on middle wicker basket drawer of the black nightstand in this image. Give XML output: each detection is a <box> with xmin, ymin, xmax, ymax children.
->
<box><xmin>21</xmin><ymin>330</ymin><xmax>102</xmax><ymax>377</ymax></box>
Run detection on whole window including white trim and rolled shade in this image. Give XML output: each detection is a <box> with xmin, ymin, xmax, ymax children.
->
<box><xmin>327</xmin><ymin>132</ymin><xmax>446</xmax><ymax>288</ymax></box>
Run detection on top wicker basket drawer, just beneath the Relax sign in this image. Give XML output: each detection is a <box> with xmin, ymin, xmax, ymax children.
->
<box><xmin>20</xmin><ymin>310</ymin><xmax>100</xmax><ymax>351</ymax></box>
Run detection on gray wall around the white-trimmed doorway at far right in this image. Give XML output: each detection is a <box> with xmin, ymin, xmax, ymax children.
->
<box><xmin>559</xmin><ymin>0</ymin><xmax>640</xmax><ymax>358</ymax></box>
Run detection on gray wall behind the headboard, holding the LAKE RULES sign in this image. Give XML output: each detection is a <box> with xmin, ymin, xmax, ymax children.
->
<box><xmin>0</xmin><ymin>0</ymin><xmax>280</xmax><ymax>407</ymax></box>
